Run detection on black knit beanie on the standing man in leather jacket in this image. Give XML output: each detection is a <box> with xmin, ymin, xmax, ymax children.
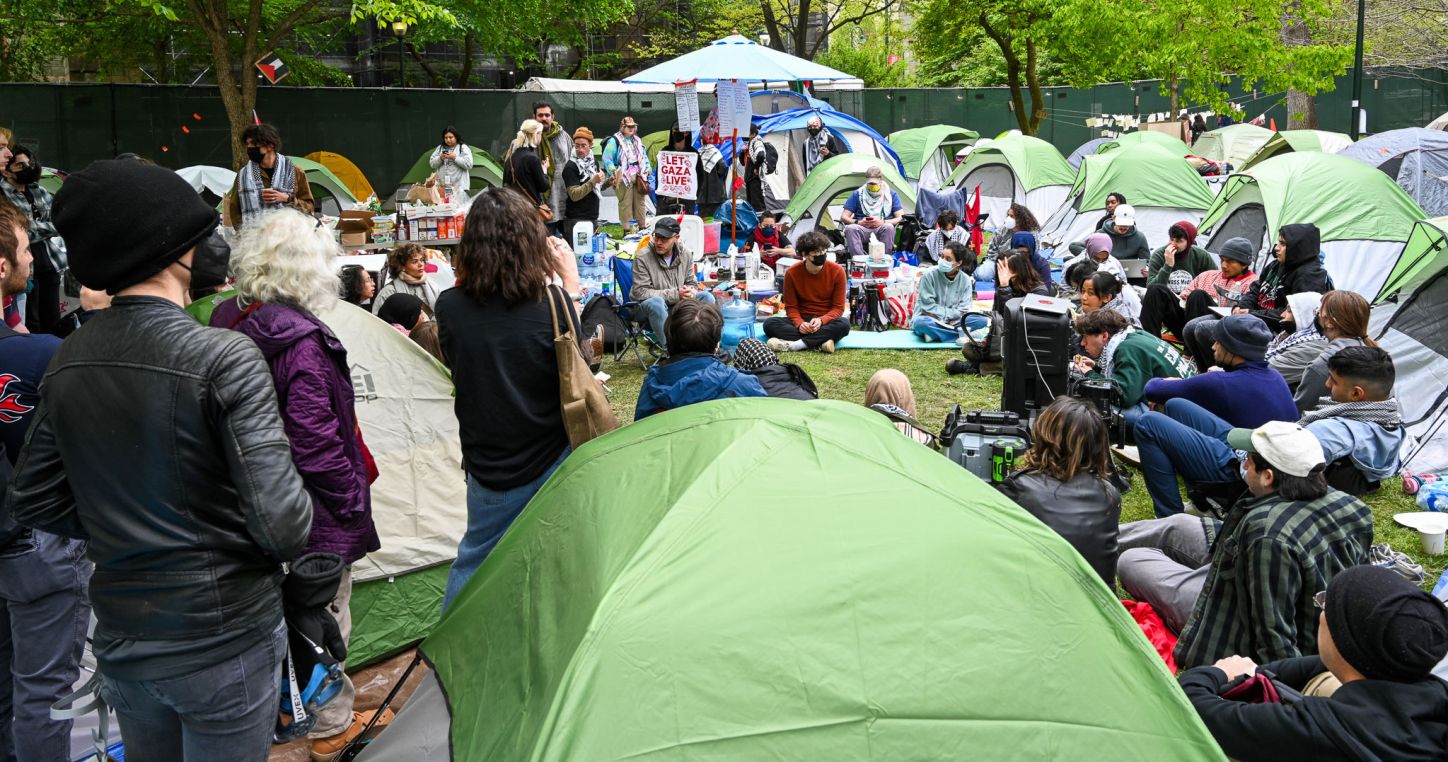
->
<box><xmin>52</xmin><ymin>159</ymin><xmax>220</xmax><ymax>294</ymax></box>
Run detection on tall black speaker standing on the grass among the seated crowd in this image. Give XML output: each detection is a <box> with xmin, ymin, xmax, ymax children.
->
<box><xmin>1001</xmin><ymin>294</ymin><xmax>1072</xmax><ymax>420</ymax></box>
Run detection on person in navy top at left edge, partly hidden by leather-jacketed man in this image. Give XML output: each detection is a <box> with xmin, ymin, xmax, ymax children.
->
<box><xmin>0</xmin><ymin>200</ymin><xmax>91</xmax><ymax>762</ymax></box>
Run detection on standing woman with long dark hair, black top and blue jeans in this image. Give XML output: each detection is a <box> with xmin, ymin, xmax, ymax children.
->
<box><xmin>437</xmin><ymin>188</ymin><xmax>582</xmax><ymax>611</ymax></box>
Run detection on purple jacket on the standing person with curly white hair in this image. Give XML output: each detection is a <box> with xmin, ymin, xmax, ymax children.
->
<box><xmin>211</xmin><ymin>298</ymin><xmax>381</xmax><ymax>564</ymax></box>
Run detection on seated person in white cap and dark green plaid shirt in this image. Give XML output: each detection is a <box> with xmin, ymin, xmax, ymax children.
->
<box><xmin>1116</xmin><ymin>420</ymin><xmax>1373</xmax><ymax>669</ymax></box>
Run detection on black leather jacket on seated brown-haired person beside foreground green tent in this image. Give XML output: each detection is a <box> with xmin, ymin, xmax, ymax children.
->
<box><xmin>999</xmin><ymin>471</ymin><xmax>1121</xmax><ymax>590</ymax></box>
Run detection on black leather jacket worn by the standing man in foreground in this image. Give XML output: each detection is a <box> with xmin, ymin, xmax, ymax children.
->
<box><xmin>9</xmin><ymin>297</ymin><xmax>311</xmax><ymax>679</ymax></box>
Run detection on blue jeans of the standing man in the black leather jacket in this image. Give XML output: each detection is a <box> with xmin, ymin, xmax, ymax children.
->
<box><xmin>101</xmin><ymin>621</ymin><xmax>287</xmax><ymax>762</ymax></box>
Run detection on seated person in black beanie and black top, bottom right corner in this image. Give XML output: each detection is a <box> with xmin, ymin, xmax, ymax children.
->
<box><xmin>1180</xmin><ymin>566</ymin><xmax>1448</xmax><ymax>762</ymax></box>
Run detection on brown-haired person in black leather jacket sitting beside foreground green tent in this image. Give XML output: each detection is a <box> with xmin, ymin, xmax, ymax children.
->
<box><xmin>998</xmin><ymin>395</ymin><xmax>1121</xmax><ymax>587</ymax></box>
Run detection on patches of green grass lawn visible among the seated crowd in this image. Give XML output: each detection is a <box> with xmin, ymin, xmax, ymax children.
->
<box><xmin>604</xmin><ymin>343</ymin><xmax>1448</xmax><ymax>588</ymax></box>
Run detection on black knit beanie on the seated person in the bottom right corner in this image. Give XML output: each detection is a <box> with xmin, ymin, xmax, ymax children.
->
<box><xmin>1325</xmin><ymin>565</ymin><xmax>1448</xmax><ymax>682</ymax></box>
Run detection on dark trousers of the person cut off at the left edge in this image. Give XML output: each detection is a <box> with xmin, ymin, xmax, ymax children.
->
<box><xmin>0</xmin><ymin>532</ymin><xmax>91</xmax><ymax>762</ymax></box>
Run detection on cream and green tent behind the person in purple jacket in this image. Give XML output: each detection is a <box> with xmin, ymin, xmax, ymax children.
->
<box><xmin>319</xmin><ymin>298</ymin><xmax>468</xmax><ymax>668</ymax></box>
